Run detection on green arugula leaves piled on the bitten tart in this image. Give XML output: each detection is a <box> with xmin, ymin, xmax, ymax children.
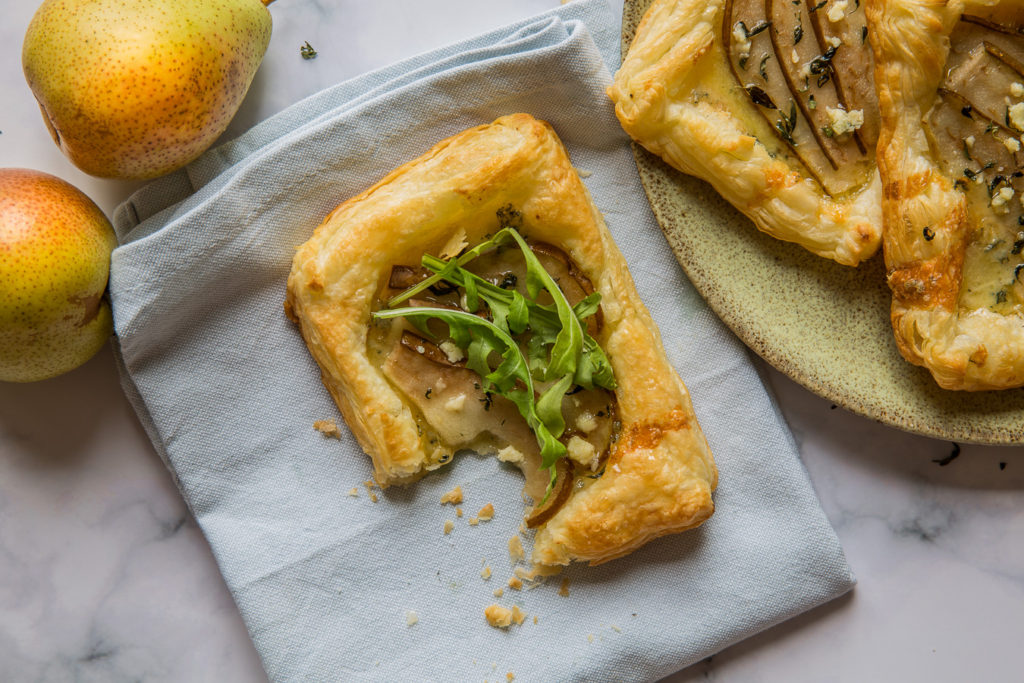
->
<box><xmin>374</xmin><ymin>227</ymin><xmax>616</xmax><ymax>497</ymax></box>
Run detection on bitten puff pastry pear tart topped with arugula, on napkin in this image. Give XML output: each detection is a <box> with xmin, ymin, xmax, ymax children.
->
<box><xmin>286</xmin><ymin>114</ymin><xmax>718</xmax><ymax>565</ymax></box>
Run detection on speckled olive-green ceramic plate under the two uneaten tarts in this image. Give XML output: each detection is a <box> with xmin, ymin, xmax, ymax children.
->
<box><xmin>623</xmin><ymin>0</ymin><xmax>1024</xmax><ymax>443</ymax></box>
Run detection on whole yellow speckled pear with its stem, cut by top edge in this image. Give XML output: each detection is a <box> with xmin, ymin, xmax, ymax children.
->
<box><xmin>22</xmin><ymin>0</ymin><xmax>272</xmax><ymax>179</ymax></box>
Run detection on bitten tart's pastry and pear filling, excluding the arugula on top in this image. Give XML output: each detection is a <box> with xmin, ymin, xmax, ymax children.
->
<box><xmin>286</xmin><ymin>114</ymin><xmax>718</xmax><ymax>565</ymax></box>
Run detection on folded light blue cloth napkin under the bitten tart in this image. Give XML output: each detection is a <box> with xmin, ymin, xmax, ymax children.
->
<box><xmin>111</xmin><ymin>0</ymin><xmax>852</xmax><ymax>683</ymax></box>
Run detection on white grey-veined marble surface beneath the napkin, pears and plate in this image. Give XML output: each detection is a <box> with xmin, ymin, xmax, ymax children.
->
<box><xmin>0</xmin><ymin>0</ymin><xmax>1024</xmax><ymax>683</ymax></box>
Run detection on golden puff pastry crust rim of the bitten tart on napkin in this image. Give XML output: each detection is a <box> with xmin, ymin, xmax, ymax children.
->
<box><xmin>286</xmin><ymin>114</ymin><xmax>718</xmax><ymax>565</ymax></box>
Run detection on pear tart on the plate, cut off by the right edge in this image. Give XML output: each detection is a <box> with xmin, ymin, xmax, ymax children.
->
<box><xmin>867</xmin><ymin>0</ymin><xmax>1024</xmax><ymax>390</ymax></box>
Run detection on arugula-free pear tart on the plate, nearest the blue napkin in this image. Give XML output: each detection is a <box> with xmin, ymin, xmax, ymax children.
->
<box><xmin>608</xmin><ymin>0</ymin><xmax>882</xmax><ymax>265</ymax></box>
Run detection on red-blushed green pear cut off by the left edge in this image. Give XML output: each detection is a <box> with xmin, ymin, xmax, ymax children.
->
<box><xmin>0</xmin><ymin>168</ymin><xmax>116</xmax><ymax>382</ymax></box>
